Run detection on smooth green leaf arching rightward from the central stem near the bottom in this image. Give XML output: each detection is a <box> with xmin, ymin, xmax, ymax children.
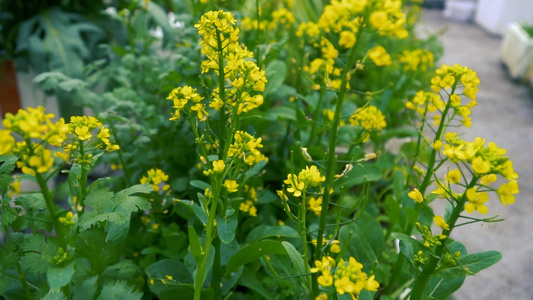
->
<box><xmin>228</xmin><ymin>240</ymin><xmax>287</xmax><ymax>272</ymax></box>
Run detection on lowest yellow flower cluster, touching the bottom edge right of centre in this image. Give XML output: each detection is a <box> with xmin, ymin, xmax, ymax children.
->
<box><xmin>311</xmin><ymin>256</ymin><xmax>379</xmax><ymax>299</ymax></box>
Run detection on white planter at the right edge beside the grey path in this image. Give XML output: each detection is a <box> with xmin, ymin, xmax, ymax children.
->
<box><xmin>501</xmin><ymin>23</ymin><xmax>533</xmax><ymax>82</ymax></box>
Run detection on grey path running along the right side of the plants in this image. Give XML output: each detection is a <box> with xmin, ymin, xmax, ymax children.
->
<box><xmin>420</xmin><ymin>10</ymin><xmax>533</xmax><ymax>300</ymax></box>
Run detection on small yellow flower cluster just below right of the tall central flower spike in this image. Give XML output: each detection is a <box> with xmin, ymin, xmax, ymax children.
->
<box><xmin>228</xmin><ymin>130</ymin><xmax>268</xmax><ymax>166</ymax></box>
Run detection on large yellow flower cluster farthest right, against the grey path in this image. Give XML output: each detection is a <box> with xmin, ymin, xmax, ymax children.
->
<box><xmin>432</xmin><ymin>132</ymin><xmax>519</xmax><ymax>214</ymax></box>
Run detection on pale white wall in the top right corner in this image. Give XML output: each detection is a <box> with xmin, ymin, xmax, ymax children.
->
<box><xmin>476</xmin><ymin>0</ymin><xmax>533</xmax><ymax>35</ymax></box>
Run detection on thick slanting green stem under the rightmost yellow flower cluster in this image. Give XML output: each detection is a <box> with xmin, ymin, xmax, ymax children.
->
<box><xmin>410</xmin><ymin>177</ymin><xmax>478</xmax><ymax>300</ymax></box>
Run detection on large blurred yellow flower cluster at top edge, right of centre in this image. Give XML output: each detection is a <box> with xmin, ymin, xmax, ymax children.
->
<box><xmin>296</xmin><ymin>0</ymin><xmax>408</xmax><ymax>90</ymax></box>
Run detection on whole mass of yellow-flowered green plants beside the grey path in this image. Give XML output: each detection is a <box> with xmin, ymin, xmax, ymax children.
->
<box><xmin>0</xmin><ymin>0</ymin><xmax>518</xmax><ymax>299</ymax></box>
